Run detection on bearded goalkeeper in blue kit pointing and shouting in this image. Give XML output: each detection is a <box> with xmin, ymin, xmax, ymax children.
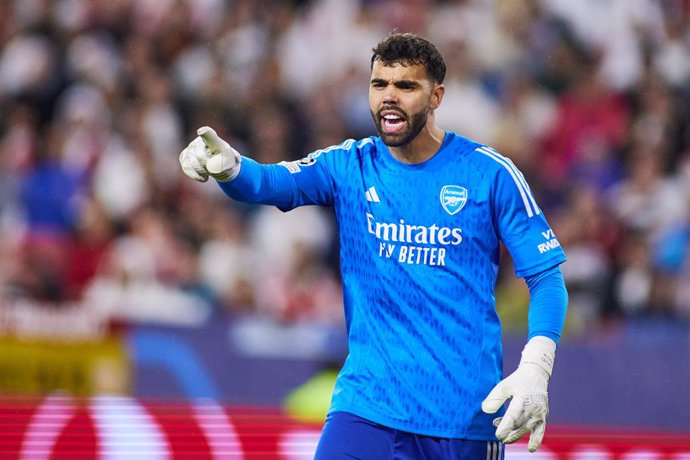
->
<box><xmin>180</xmin><ymin>34</ymin><xmax>567</xmax><ymax>460</ymax></box>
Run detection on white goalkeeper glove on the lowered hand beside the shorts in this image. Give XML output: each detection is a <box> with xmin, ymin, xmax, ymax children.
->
<box><xmin>482</xmin><ymin>336</ymin><xmax>556</xmax><ymax>452</ymax></box>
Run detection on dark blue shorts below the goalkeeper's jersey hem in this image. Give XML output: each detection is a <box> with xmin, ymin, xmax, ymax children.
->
<box><xmin>314</xmin><ymin>412</ymin><xmax>504</xmax><ymax>460</ymax></box>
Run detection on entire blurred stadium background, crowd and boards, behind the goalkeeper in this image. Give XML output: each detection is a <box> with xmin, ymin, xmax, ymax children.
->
<box><xmin>0</xmin><ymin>0</ymin><xmax>690</xmax><ymax>459</ymax></box>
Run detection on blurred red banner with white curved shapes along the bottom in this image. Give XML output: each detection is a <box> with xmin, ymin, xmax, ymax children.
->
<box><xmin>0</xmin><ymin>396</ymin><xmax>690</xmax><ymax>460</ymax></box>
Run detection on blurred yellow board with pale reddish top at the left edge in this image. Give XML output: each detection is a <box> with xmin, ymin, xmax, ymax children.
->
<box><xmin>0</xmin><ymin>303</ymin><xmax>132</xmax><ymax>396</ymax></box>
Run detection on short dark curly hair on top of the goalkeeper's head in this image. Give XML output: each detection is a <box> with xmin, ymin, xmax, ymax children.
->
<box><xmin>371</xmin><ymin>33</ymin><xmax>446</xmax><ymax>83</ymax></box>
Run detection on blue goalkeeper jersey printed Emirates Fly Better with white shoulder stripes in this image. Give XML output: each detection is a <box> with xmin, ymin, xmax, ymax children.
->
<box><xmin>221</xmin><ymin>132</ymin><xmax>565</xmax><ymax>440</ymax></box>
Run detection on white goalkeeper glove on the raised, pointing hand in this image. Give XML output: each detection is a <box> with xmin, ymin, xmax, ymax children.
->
<box><xmin>180</xmin><ymin>126</ymin><xmax>242</xmax><ymax>182</ymax></box>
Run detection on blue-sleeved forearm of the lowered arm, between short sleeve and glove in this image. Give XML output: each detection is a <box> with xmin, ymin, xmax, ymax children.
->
<box><xmin>525</xmin><ymin>265</ymin><xmax>568</xmax><ymax>344</ymax></box>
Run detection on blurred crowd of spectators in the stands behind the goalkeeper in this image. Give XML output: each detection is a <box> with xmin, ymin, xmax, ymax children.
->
<box><xmin>0</xmin><ymin>0</ymin><xmax>690</xmax><ymax>342</ymax></box>
